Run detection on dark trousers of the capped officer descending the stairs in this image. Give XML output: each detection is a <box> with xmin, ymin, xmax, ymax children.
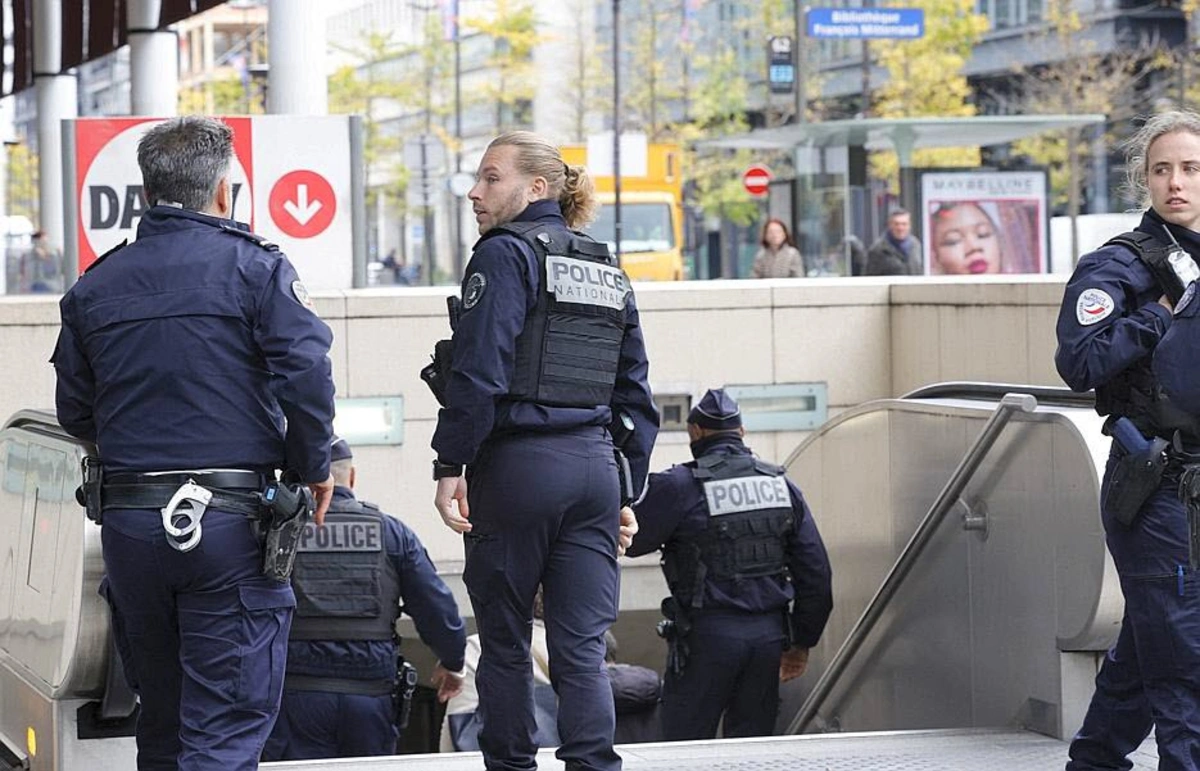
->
<box><xmin>662</xmin><ymin>610</ymin><xmax>785</xmax><ymax>741</ymax></box>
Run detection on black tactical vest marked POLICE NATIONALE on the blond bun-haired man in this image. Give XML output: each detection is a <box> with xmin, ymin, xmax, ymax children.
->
<box><xmin>487</xmin><ymin>222</ymin><xmax>630</xmax><ymax>407</ymax></box>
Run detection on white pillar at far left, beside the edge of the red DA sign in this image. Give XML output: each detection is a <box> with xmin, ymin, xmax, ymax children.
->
<box><xmin>34</xmin><ymin>0</ymin><xmax>79</xmax><ymax>254</ymax></box>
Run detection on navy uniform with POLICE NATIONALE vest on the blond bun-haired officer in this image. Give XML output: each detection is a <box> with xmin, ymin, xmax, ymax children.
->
<box><xmin>433</xmin><ymin>201</ymin><xmax>659</xmax><ymax>771</ymax></box>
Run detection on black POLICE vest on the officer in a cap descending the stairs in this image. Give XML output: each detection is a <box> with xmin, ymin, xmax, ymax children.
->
<box><xmin>662</xmin><ymin>453</ymin><xmax>792</xmax><ymax>609</ymax></box>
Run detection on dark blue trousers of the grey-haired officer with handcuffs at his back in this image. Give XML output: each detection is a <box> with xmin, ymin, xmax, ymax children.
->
<box><xmin>101</xmin><ymin>509</ymin><xmax>295</xmax><ymax>771</ymax></box>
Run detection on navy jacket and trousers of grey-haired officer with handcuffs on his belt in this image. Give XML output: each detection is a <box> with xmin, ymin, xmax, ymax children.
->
<box><xmin>53</xmin><ymin>205</ymin><xmax>334</xmax><ymax>771</ymax></box>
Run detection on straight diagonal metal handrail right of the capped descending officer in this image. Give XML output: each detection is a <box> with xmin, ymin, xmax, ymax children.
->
<box><xmin>787</xmin><ymin>393</ymin><xmax>1038</xmax><ymax>734</ymax></box>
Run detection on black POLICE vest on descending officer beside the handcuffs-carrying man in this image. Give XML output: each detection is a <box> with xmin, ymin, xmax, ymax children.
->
<box><xmin>290</xmin><ymin>501</ymin><xmax>400</xmax><ymax>640</ymax></box>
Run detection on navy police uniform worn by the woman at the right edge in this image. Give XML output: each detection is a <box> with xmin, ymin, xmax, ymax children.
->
<box><xmin>1055</xmin><ymin>205</ymin><xmax>1200</xmax><ymax>771</ymax></box>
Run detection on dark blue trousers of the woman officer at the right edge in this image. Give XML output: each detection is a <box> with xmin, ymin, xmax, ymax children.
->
<box><xmin>1067</xmin><ymin>459</ymin><xmax>1200</xmax><ymax>771</ymax></box>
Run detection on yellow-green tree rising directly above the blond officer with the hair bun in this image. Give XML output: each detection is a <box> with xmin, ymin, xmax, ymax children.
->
<box><xmin>464</xmin><ymin>0</ymin><xmax>542</xmax><ymax>133</ymax></box>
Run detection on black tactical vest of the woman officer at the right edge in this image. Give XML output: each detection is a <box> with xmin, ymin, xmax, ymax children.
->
<box><xmin>1096</xmin><ymin>231</ymin><xmax>1200</xmax><ymax>446</ymax></box>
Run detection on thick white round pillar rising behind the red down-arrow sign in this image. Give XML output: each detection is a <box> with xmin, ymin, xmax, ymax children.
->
<box><xmin>266</xmin><ymin>0</ymin><xmax>329</xmax><ymax>115</ymax></box>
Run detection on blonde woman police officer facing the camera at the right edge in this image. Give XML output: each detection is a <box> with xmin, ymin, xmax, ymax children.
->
<box><xmin>1055</xmin><ymin>112</ymin><xmax>1200</xmax><ymax>771</ymax></box>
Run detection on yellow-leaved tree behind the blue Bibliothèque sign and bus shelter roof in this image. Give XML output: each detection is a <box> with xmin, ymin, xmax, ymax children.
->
<box><xmin>871</xmin><ymin>0</ymin><xmax>988</xmax><ymax>190</ymax></box>
